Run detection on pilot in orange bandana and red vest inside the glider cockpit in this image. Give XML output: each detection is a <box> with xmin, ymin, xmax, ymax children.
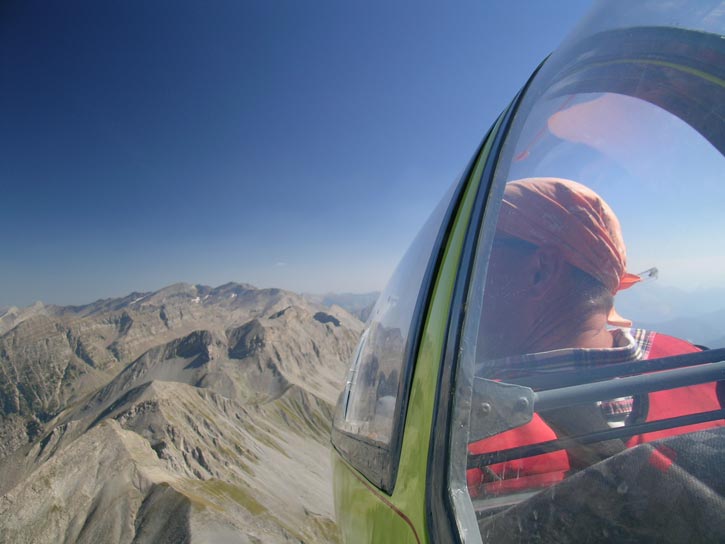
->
<box><xmin>468</xmin><ymin>178</ymin><xmax>724</xmax><ymax>496</ymax></box>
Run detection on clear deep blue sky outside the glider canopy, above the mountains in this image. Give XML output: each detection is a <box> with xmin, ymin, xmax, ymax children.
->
<box><xmin>0</xmin><ymin>0</ymin><xmax>589</xmax><ymax>306</ymax></box>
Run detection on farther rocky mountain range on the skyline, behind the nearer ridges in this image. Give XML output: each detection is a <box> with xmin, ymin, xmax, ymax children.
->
<box><xmin>0</xmin><ymin>283</ymin><xmax>360</xmax><ymax>457</ymax></box>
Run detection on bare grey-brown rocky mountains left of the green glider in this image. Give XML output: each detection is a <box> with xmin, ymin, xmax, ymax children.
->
<box><xmin>0</xmin><ymin>284</ymin><xmax>363</xmax><ymax>543</ymax></box>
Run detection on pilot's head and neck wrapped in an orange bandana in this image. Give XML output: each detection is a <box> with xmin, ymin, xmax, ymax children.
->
<box><xmin>479</xmin><ymin>178</ymin><xmax>639</xmax><ymax>358</ymax></box>
